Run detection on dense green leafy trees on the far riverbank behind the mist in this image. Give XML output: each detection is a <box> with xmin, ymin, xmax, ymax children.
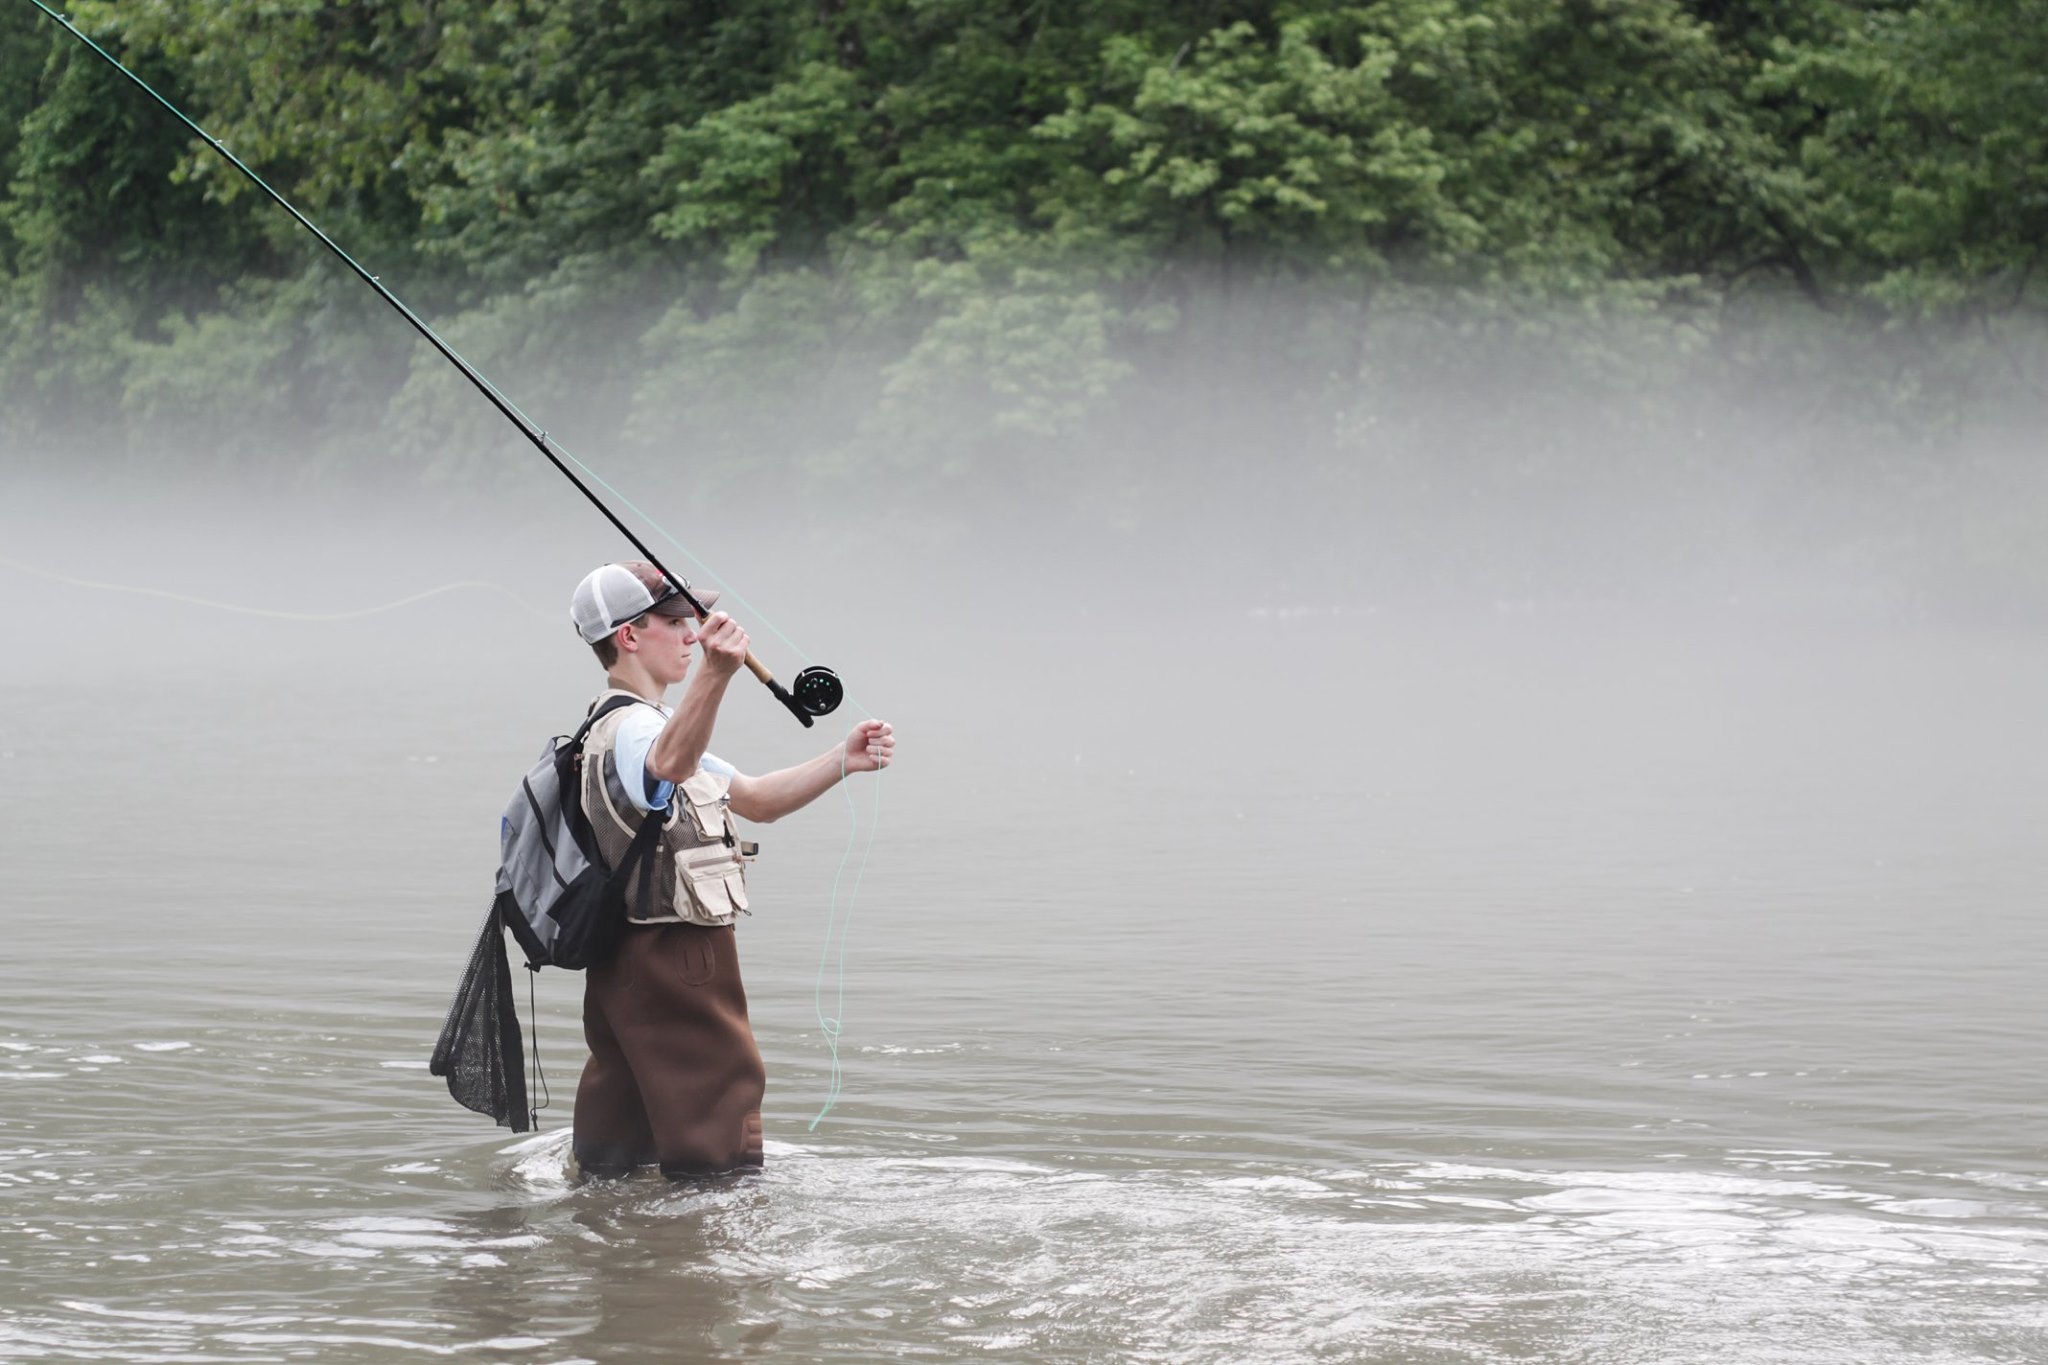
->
<box><xmin>0</xmin><ymin>0</ymin><xmax>2048</xmax><ymax>477</ymax></box>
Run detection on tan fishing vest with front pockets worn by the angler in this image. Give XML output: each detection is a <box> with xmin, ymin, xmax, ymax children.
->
<box><xmin>584</xmin><ymin>690</ymin><xmax>754</xmax><ymax>927</ymax></box>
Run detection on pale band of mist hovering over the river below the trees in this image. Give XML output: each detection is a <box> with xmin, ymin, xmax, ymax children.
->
<box><xmin>0</xmin><ymin>301</ymin><xmax>2048</xmax><ymax>908</ymax></box>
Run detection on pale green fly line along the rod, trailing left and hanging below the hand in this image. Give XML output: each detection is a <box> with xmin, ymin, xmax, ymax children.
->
<box><xmin>25</xmin><ymin>0</ymin><xmax>881</xmax><ymax>1128</ymax></box>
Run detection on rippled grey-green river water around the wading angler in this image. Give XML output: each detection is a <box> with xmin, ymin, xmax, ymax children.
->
<box><xmin>0</xmin><ymin>493</ymin><xmax>2048</xmax><ymax>1365</ymax></box>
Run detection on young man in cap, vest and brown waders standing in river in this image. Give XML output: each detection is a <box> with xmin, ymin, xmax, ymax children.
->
<box><xmin>569</xmin><ymin>561</ymin><xmax>895</xmax><ymax>1177</ymax></box>
